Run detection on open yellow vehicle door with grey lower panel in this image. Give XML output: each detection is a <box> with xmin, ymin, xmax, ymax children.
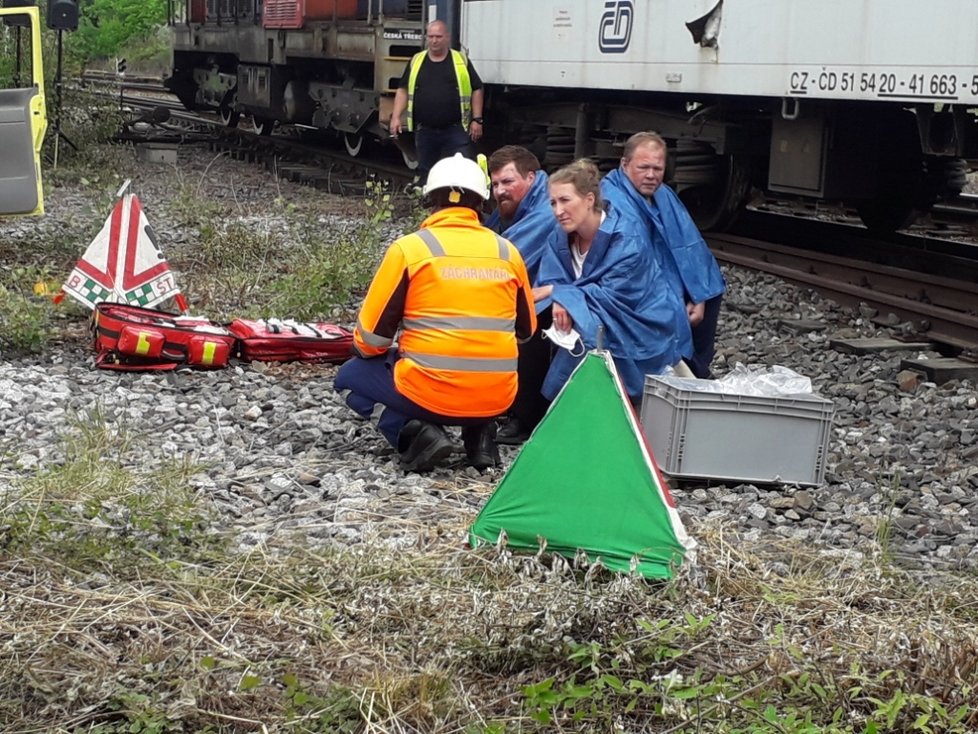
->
<box><xmin>0</xmin><ymin>7</ymin><xmax>48</xmax><ymax>216</ymax></box>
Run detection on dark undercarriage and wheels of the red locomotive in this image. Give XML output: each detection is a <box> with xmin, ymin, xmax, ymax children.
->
<box><xmin>166</xmin><ymin>10</ymin><xmax>423</xmax><ymax>168</ymax></box>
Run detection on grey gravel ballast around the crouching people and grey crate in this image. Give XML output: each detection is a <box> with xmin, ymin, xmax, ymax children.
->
<box><xmin>0</xmin><ymin>151</ymin><xmax>978</xmax><ymax>570</ymax></box>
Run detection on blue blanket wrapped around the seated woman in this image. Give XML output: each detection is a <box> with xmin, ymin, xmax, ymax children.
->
<box><xmin>536</xmin><ymin>207</ymin><xmax>689</xmax><ymax>402</ymax></box>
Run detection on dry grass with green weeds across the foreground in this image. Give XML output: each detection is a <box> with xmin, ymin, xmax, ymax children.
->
<box><xmin>0</xmin><ymin>506</ymin><xmax>978</xmax><ymax>732</ymax></box>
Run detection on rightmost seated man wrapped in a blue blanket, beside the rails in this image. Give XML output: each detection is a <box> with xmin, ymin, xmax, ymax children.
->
<box><xmin>601</xmin><ymin>132</ymin><xmax>726</xmax><ymax>378</ymax></box>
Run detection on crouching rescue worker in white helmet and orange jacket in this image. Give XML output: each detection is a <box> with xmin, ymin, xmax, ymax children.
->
<box><xmin>335</xmin><ymin>153</ymin><xmax>536</xmax><ymax>471</ymax></box>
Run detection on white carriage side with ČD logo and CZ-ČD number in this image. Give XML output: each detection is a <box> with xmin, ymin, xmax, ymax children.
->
<box><xmin>462</xmin><ymin>0</ymin><xmax>978</xmax><ymax>104</ymax></box>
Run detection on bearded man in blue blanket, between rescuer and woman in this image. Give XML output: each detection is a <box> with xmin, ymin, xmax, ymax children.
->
<box><xmin>486</xmin><ymin>145</ymin><xmax>559</xmax><ymax>445</ymax></box>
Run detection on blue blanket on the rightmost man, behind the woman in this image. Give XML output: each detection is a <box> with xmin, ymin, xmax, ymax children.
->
<box><xmin>601</xmin><ymin>168</ymin><xmax>726</xmax><ymax>303</ymax></box>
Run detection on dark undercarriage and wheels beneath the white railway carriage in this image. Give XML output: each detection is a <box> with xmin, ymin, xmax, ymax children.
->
<box><xmin>487</xmin><ymin>88</ymin><xmax>978</xmax><ymax>231</ymax></box>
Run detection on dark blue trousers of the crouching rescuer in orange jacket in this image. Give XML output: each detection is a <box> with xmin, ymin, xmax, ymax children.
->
<box><xmin>333</xmin><ymin>354</ymin><xmax>488</xmax><ymax>449</ymax></box>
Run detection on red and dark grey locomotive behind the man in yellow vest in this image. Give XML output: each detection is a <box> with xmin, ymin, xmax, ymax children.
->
<box><xmin>165</xmin><ymin>0</ymin><xmax>425</xmax><ymax>166</ymax></box>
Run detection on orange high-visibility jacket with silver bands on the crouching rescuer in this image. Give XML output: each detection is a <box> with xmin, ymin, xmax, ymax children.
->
<box><xmin>353</xmin><ymin>207</ymin><xmax>536</xmax><ymax>418</ymax></box>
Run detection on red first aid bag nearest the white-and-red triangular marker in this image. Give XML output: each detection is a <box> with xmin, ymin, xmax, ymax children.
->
<box><xmin>92</xmin><ymin>302</ymin><xmax>237</xmax><ymax>371</ymax></box>
